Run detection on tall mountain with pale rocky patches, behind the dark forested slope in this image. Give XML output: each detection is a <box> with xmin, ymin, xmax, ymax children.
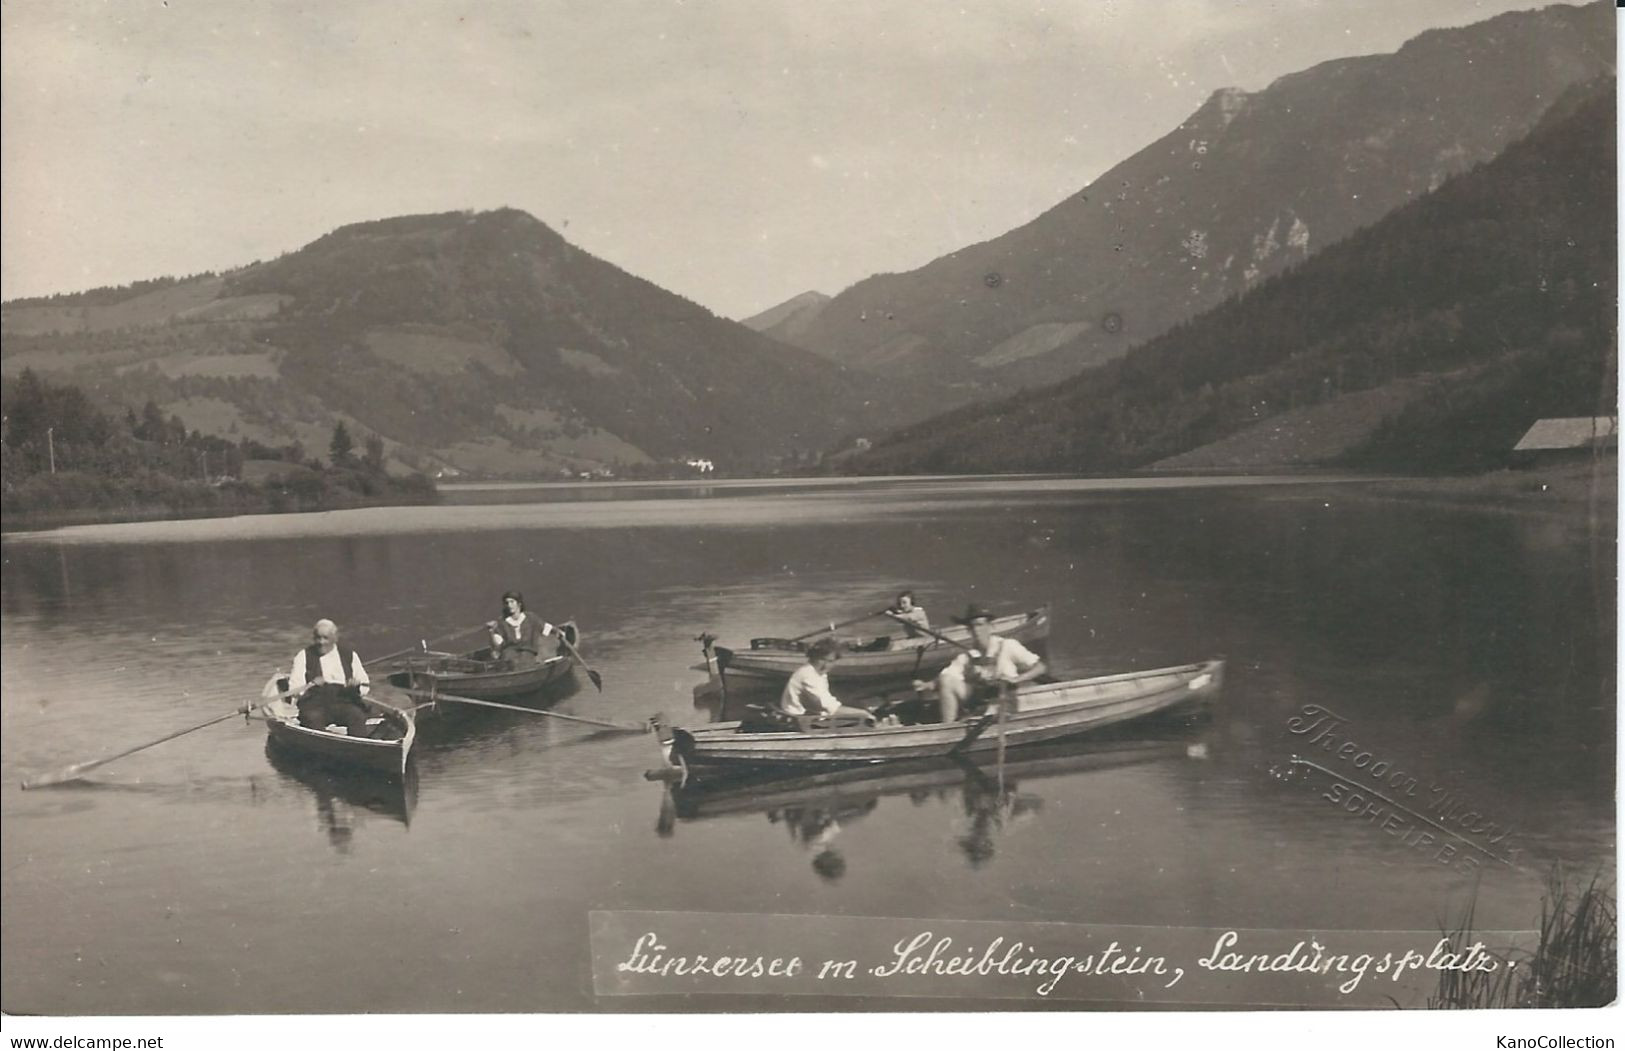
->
<box><xmin>777</xmin><ymin>3</ymin><xmax>1614</xmax><ymax>398</ymax></box>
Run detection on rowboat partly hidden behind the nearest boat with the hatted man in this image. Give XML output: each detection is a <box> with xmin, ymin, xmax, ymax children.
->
<box><xmin>700</xmin><ymin>606</ymin><xmax>1050</xmax><ymax>686</ymax></box>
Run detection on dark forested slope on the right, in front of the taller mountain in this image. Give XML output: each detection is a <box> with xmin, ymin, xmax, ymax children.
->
<box><xmin>845</xmin><ymin>76</ymin><xmax>1619</xmax><ymax>473</ymax></box>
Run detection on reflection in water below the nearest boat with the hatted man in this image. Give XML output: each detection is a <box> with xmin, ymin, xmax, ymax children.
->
<box><xmin>655</xmin><ymin>726</ymin><xmax>1204</xmax><ymax>880</ymax></box>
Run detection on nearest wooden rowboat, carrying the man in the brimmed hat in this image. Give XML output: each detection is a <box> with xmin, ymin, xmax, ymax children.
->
<box><xmin>668</xmin><ymin>661</ymin><xmax>1224</xmax><ymax>778</ymax></box>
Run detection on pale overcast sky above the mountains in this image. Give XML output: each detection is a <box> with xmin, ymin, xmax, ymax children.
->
<box><xmin>0</xmin><ymin>0</ymin><xmax>1573</xmax><ymax>317</ymax></box>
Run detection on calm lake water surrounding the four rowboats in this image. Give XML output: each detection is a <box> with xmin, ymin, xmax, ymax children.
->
<box><xmin>0</xmin><ymin>479</ymin><xmax>1615</xmax><ymax>1015</ymax></box>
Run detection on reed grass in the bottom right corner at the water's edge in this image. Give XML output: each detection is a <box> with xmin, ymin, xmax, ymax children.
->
<box><xmin>1427</xmin><ymin>869</ymin><xmax>1619</xmax><ymax>1009</ymax></box>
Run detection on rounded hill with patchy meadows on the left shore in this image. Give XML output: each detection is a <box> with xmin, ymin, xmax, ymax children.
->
<box><xmin>0</xmin><ymin>210</ymin><xmax>876</xmax><ymax>474</ymax></box>
